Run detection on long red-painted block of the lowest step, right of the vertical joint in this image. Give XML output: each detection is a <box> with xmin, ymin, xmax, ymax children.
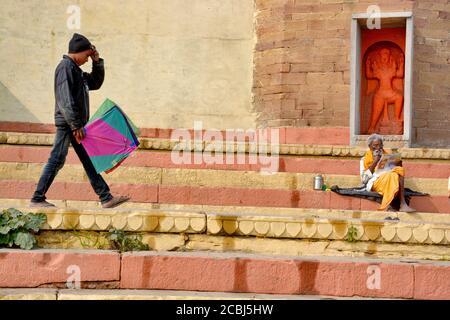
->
<box><xmin>120</xmin><ymin>253</ymin><xmax>450</xmax><ymax>299</ymax></box>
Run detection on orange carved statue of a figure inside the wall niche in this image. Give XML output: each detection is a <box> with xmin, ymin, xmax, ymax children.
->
<box><xmin>365</xmin><ymin>48</ymin><xmax>404</xmax><ymax>134</ymax></box>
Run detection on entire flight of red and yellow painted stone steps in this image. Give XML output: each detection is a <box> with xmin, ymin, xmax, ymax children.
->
<box><xmin>0</xmin><ymin>133</ymin><xmax>450</xmax><ymax>299</ymax></box>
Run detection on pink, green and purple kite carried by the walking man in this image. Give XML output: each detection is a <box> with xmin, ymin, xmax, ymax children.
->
<box><xmin>81</xmin><ymin>99</ymin><xmax>139</xmax><ymax>173</ymax></box>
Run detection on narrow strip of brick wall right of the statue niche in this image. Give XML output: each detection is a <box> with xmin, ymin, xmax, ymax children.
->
<box><xmin>413</xmin><ymin>0</ymin><xmax>450</xmax><ymax>147</ymax></box>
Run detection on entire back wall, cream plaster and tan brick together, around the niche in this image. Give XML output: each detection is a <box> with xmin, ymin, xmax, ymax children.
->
<box><xmin>0</xmin><ymin>0</ymin><xmax>450</xmax><ymax>147</ymax></box>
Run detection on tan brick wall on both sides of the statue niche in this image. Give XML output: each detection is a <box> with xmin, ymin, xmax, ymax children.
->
<box><xmin>253</xmin><ymin>0</ymin><xmax>450</xmax><ymax>147</ymax></box>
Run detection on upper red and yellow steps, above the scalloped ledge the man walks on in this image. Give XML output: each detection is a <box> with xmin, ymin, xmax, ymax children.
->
<box><xmin>0</xmin><ymin>132</ymin><xmax>450</xmax><ymax>213</ymax></box>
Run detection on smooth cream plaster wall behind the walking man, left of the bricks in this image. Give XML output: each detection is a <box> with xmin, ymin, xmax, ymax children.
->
<box><xmin>0</xmin><ymin>0</ymin><xmax>255</xmax><ymax>129</ymax></box>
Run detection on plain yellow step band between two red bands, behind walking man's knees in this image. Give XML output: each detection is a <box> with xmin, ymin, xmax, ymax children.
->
<box><xmin>0</xmin><ymin>162</ymin><xmax>448</xmax><ymax>196</ymax></box>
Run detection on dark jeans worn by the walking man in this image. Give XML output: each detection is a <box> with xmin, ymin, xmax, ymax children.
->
<box><xmin>31</xmin><ymin>127</ymin><xmax>112</xmax><ymax>203</ymax></box>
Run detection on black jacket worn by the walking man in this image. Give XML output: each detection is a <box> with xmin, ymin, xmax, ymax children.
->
<box><xmin>55</xmin><ymin>55</ymin><xmax>105</xmax><ymax>130</ymax></box>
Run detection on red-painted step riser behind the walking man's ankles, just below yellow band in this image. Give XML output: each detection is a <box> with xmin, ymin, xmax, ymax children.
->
<box><xmin>0</xmin><ymin>180</ymin><xmax>450</xmax><ymax>213</ymax></box>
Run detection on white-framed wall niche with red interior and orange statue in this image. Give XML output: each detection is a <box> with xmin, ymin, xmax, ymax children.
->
<box><xmin>350</xmin><ymin>12</ymin><xmax>413</xmax><ymax>147</ymax></box>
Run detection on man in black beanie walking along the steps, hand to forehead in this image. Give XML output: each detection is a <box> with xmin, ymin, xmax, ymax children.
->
<box><xmin>30</xmin><ymin>33</ymin><xmax>130</xmax><ymax>208</ymax></box>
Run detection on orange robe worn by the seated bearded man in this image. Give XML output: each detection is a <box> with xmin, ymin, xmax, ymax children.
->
<box><xmin>364</xmin><ymin>149</ymin><xmax>405</xmax><ymax>210</ymax></box>
